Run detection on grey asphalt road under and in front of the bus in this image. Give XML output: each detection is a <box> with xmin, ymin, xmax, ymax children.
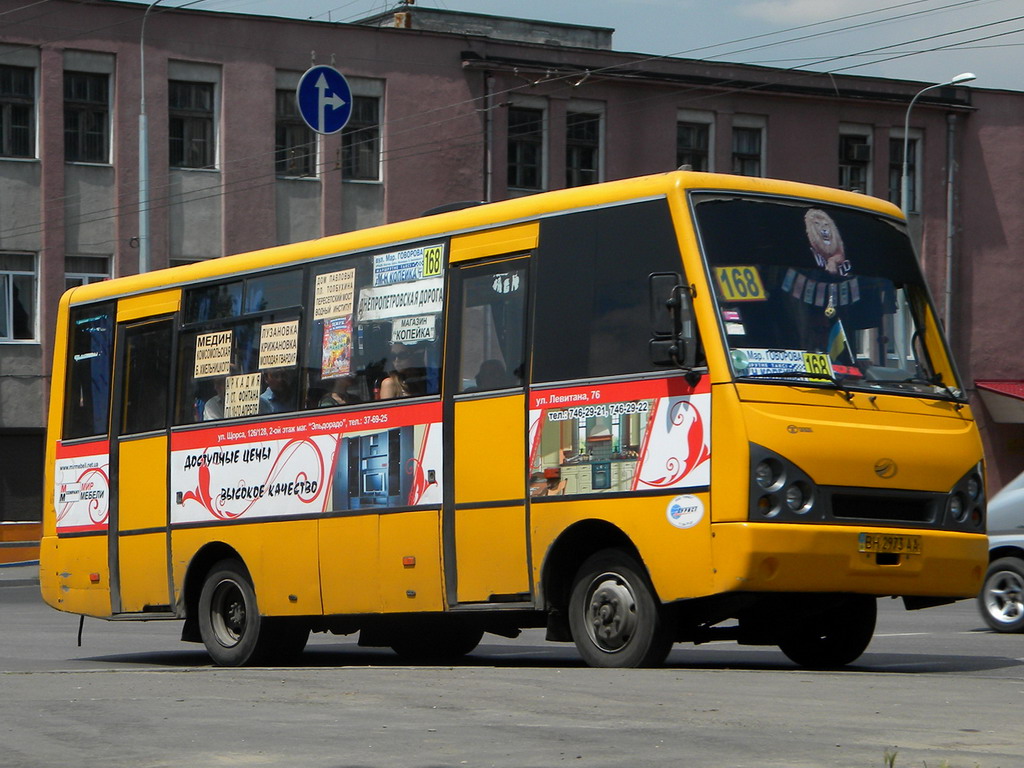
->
<box><xmin>0</xmin><ymin>571</ymin><xmax>1024</xmax><ymax>768</ymax></box>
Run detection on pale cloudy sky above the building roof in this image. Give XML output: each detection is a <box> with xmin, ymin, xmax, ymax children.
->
<box><xmin>141</xmin><ymin>0</ymin><xmax>1024</xmax><ymax>91</ymax></box>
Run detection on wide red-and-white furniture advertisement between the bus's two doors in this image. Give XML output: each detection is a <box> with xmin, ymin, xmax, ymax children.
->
<box><xmin>171</xmin><ymin>403</ymin><xmax>442</xmax><ymax>524</ymax></box>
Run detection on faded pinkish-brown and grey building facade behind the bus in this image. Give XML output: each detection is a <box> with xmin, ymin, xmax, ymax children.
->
<box><xmin>0</xmin><ymin>0</ymin><xmax>1024</xmax><ymax>520</ymax></box>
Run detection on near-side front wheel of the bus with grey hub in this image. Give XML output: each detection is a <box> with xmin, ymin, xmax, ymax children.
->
<box><xmin>569</xmin><ymin>549</ymin><xmax>672</xmax><ymax>668</ymax></box>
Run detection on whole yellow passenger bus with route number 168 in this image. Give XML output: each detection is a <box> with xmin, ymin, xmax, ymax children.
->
<box><xmin>41</xmin><ymin>172</ymin><xmax>987</xmax><ymax>668</ymax></box>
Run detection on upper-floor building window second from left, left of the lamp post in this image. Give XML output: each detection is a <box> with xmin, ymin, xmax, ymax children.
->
<box><xmin>65</xmin><ymin>72</ymin><xmax>110</xmax><ymax>163</ymax></box>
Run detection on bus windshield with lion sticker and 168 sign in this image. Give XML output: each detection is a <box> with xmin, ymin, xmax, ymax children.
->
<box><xmin>692</xmin><ymin>194</ymin><xmax>964</xmax><ymax>400</ymax></box>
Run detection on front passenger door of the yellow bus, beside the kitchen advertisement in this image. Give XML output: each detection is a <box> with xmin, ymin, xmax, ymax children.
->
<box><xmin>443</xmin><ymin>252</ymin><xmax>531</xmax><ymax>605</ymax></box>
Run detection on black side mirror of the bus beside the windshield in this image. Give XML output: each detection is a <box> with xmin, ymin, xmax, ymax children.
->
<box><xmin>648</xmin><ymin>272</ymin><xmax>697</xmax><ymax>369</ymax></box>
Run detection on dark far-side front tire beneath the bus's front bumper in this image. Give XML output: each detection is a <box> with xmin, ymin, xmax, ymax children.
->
<box><xmin>778</xmin><ymin>595</ymin><xmax>878</xmax><ymax>670</ymax></box>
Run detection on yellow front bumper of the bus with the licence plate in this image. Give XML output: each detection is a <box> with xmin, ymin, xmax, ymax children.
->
<box><xmin>712</xmin><ymin>522</ymin><xmax>988</xmax><ymax>598</ymax></box>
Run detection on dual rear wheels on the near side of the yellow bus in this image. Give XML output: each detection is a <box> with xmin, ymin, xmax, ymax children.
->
<box><xmin>199</xmin><ymin>559</ymin><xmax>309</xmax><ymax>667</ymax></box>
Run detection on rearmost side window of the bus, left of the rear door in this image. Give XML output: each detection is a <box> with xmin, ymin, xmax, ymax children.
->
<box><xmin>63</xmin><ymin>304</ymin><xmax>114</xmax><ymax>440</ymax></box>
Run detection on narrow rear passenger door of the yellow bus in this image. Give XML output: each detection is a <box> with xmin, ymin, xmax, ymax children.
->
<box><xmin>109</xmin><ymin>291</ymin><xmax>179</xmax><ymax>613</ymax></box>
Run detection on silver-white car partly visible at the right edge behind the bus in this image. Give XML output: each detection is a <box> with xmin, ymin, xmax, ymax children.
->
<box><xmin>978</xmin><ymin>472</ymin><xmax>1024</xmax><ymax>632</ymax></box>
